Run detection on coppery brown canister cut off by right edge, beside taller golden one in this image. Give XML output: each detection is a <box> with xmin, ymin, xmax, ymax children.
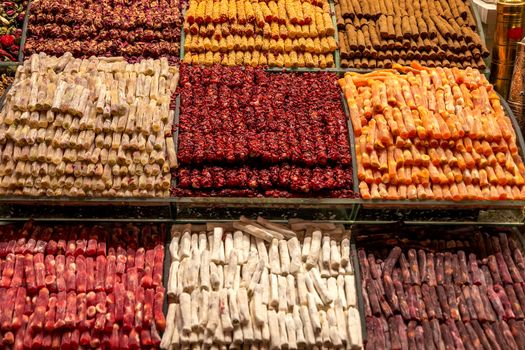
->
<box><xmin>508</xmin><ymin>39</ymin><xmax>525</xmax><ymax>123</ymax></box>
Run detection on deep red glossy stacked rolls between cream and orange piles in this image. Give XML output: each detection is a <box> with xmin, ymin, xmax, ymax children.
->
<box><xmin>173</xmin><ymin>65</ymin><xmax>354</xmax><ymax>197</ymax></box>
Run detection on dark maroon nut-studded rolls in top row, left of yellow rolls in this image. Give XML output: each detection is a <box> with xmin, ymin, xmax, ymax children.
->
<box><xmin>25</xmin><ymin>0</ymin><xmax>182</xmax><ymax>61</ymax></box>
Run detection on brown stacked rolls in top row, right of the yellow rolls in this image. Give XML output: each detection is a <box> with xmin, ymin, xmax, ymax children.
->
<box><xmin>335</xmin><ymin>0</ymin><xmax>489</xmax><ymax>69</ymax></box>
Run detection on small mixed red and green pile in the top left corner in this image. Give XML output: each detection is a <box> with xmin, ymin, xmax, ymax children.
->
<box><xmin>0</xmin><ymin>0</ymin><xmax>27</xmax><ymax>62</ymax></box>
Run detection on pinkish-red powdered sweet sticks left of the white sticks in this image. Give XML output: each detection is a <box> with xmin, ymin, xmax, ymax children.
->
<box><xmin>0</xmin><ymin>222</ymin><xmax>166</xmax><ymax>349</ymax></box>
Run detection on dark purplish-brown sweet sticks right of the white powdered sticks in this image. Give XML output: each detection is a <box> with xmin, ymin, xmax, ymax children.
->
<box><xmin>358</xmin><ymin>228</ymin><xmax>525</xmax><ymax>350</ymax></box>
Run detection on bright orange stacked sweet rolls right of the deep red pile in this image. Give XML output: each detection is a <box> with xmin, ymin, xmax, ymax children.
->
<box><xmin>339</xmin><ymin>65</ymin><xmax>525</xmax><ymax>201</ymax></box>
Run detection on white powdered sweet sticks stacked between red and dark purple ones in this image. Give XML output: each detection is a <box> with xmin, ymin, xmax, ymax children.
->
<box><xmin>161</xmin><ymin>218</ymin><xmax>362</xmax><ymax>349</ymax></box>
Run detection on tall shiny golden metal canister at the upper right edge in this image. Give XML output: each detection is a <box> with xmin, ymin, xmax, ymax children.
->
<box><xmin>490</xmin><ymin>0</ymin><xmax>525</xmax><ymax>98</ymax></box>
